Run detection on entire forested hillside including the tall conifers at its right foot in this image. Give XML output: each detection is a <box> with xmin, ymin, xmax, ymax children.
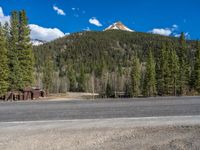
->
<box><xmin>34</xmin><ymin>30</ymin><xmax>200</xmax><ymax>96</ymax></box>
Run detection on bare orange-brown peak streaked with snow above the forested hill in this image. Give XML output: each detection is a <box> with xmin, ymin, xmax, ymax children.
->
<box><xmin>104</xmin><ymin>21</ymin><xmax>134</xmax><ymax>32</ymax></box>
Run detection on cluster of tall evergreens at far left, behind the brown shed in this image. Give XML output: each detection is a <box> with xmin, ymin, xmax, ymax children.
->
<box><xmin>0</xmin><ymin>10</ymin><xmax>35</xmax><ymax>96</ymax></box>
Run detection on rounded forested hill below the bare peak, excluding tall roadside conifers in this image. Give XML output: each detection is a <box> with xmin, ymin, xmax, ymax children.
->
<box><xmin>33</xmin><ymin>30</ymin><xmax>195</xmax><ymax>93</ymax></box>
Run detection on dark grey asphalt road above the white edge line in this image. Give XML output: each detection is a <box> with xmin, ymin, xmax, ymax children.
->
<box><xmin>0</xmin><ymin>97</ymin><xmax>200</xmax><ymax>122</ymax></box>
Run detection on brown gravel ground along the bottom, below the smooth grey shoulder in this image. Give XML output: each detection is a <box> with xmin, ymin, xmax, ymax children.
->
<box><xmin>0</xmin><ymin>126</ymin><xmax>200</xmax><ymax>150</ymax></box>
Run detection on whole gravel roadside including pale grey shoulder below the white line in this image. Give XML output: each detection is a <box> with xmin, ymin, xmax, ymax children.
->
<box><xmin>0</xmin><ymin>116</ymin><xmax>200</xmax><ymax>150</ymax></box>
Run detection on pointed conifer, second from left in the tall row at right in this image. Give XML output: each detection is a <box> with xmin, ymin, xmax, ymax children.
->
<box><xmin>144</xmin><ymin>50</ymin><xmax>157</xmax><ymax>96</ymax></box>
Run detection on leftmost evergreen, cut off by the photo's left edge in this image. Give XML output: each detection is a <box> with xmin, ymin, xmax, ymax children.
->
<box><xmin>0</xmin><ymin>24</ymin><xmax>9</xmax><ymax>97</ymax></box>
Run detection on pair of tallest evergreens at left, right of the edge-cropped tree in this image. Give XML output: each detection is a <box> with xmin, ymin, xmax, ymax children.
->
<box><xmin>0</xmin><ymin>11</ymin><xmax>34</xmax><ymax>91</ymax></box>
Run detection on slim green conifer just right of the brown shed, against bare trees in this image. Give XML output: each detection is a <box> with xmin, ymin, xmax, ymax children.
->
<box><xmin>42</xmin><ymin>56</ymin><xmax>53</xmax><ymax>95</ymax></box>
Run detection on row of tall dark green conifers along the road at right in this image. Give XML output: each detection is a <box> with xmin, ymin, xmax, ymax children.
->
<box><xmin>130</xmin><ymin>36</ymin><xmax>200</xmax><ymax>96</ymax></box>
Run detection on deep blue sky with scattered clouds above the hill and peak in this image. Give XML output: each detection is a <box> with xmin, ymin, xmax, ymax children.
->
<box><xmin>0</xmin><ymin>0</ymin><xmax>200</xmax><ymax>40</ymax></box>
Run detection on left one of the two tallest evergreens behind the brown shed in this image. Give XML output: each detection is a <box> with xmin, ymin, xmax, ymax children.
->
<box><xmin>8</xmin><ymin>11</ymin><xmax>23</xmax><ymax>90</ymax></box>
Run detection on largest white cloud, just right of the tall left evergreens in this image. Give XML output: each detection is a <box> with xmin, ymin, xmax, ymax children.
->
<box><xmin>29</xmin><ymin>24</ymin><xmax>65</xmax><ymax>41</ymax></box>
